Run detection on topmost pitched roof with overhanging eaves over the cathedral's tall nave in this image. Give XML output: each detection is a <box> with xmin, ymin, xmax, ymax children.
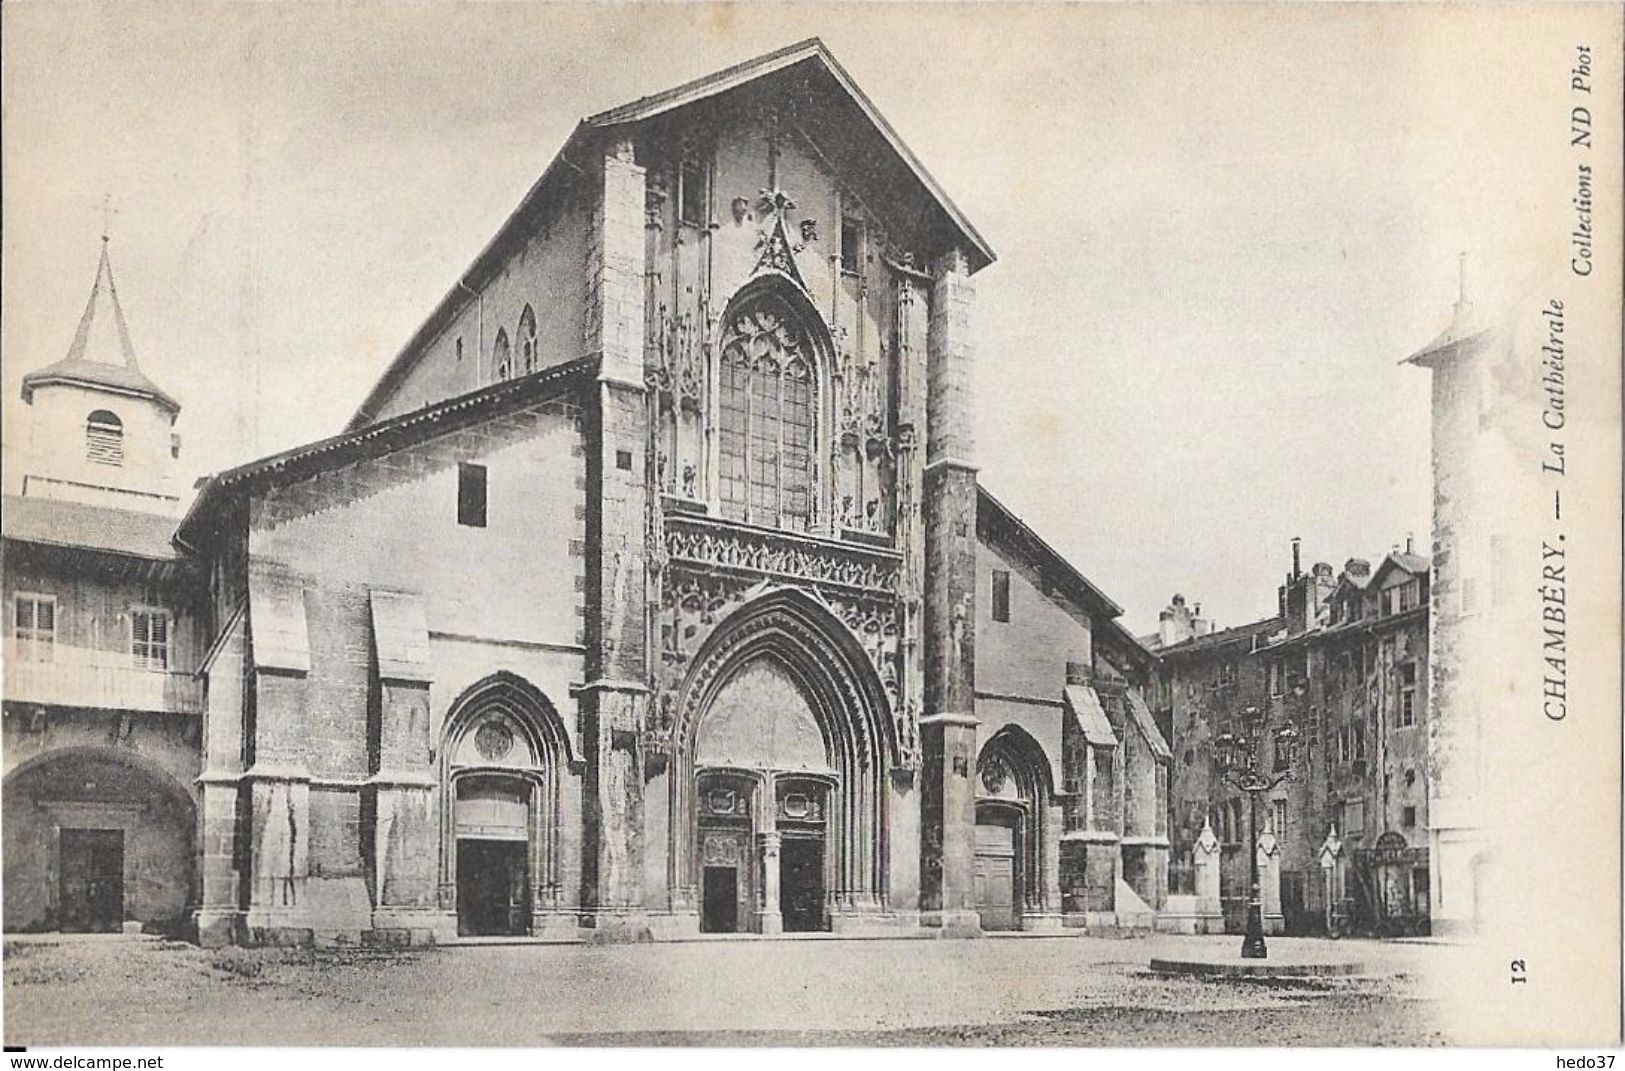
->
<box><xmin>346</xmin><ymin>37</ymin><xmax>995</xmax><ymax>431</ymax></box>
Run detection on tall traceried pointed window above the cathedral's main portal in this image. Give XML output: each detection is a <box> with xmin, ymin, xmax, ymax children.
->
<box><xmin>718</xmin><ymin>302</ymin><xmax>817</xmax><ymax>530</ymax></box>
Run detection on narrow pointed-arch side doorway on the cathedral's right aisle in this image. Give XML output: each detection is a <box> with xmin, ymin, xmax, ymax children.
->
<box><xmin>975</xmin><ymin>725</ymin><xmax>1058</xmax><ymax>930</ymax></box>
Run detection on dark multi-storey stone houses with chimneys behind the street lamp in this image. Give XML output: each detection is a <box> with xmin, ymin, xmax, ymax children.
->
<box><xmin>1149</xmin><ymin>541</ymin><xmax>1432</xmax><ymax>933</ymax></box>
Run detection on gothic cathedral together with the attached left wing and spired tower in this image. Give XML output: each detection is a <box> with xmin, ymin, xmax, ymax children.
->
<box><xmin>3</xmin><ymin>39</ymin><xmax>1170</xmax><ymax>944</ymax></box>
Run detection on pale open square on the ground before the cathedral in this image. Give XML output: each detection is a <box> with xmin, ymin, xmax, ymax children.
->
<box><xmin>5</xmin><ymin>936</ymin><xmax>1458</xmax><ymax>1047</ymax></box>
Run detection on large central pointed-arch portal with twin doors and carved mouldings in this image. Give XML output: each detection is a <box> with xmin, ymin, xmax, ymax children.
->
<box><xmin>670</xmin><ymin>590</ymin><xmax>895</xmax><ymax>933</ymax></box>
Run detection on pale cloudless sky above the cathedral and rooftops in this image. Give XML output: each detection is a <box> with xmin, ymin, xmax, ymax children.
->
<box><xmin>0</xmin><ymin>3</ymin><xmax>1571</xmax><ymax>632</ymax></box>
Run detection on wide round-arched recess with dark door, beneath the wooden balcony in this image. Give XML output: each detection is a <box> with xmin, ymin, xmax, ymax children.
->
<box><xmin>3</xmin><ymin>748</ymin><xmax>197</xmax><ymax>933</ymax></box>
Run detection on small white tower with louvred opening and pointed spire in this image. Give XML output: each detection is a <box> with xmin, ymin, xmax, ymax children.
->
<box><xmin>23</xmin><ymin>234</ymin><xmax>180</xmax><ymax>514</ymax></box>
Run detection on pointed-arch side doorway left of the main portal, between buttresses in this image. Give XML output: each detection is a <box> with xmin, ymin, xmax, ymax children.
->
<box><xmin>440</xmin><ymin>673</ymin><xmax>570</xmax><ymax>936</ymax></box>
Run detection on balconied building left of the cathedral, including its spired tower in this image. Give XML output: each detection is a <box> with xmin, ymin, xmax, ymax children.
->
<box><xmin>0</xmin><ymin>241</ymin><xmax>206</xmax><ymax>931</ymax></box>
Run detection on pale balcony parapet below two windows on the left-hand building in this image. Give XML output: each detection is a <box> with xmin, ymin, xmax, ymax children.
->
<box><xmin>5</xmin><ymin>640</ymin><xmax>203</xmax><ymax>713</ymax></box>
